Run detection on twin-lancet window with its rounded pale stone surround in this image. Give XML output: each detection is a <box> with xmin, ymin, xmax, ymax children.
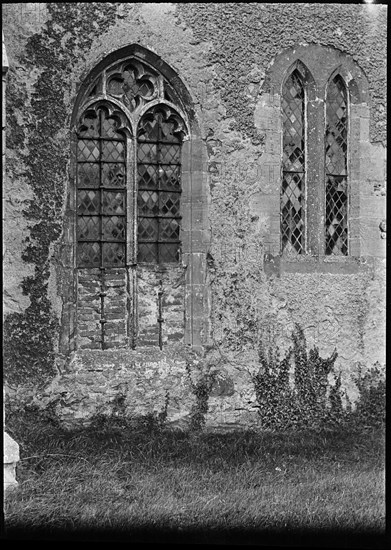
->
<box><xmin>262</xmin><ymin>44</ymin><xmax>370</xmax><ymax>262</ymax></box>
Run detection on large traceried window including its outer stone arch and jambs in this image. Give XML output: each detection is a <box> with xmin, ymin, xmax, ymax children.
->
<box><xmin>61</xmin><ymin>45</ymin><xmax>208</xmax><ymax>353</ymax></box>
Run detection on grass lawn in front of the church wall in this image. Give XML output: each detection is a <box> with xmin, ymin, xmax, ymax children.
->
<box><xmin>5</xmin><ymin>412</ymin><xmax>385</xmax><ymax>548</ymax></box>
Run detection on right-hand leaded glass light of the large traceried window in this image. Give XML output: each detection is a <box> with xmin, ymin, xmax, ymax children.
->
<box><xmin>137</xmin><ymin>107</ymin><xmax>183</xmax><ymax>263</ymax></box>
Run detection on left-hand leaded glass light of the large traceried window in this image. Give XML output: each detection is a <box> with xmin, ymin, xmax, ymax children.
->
<box><xmin>77</xmin><ymin>108</ymin><xmax>126</xmax><ymax>267</ymax></box>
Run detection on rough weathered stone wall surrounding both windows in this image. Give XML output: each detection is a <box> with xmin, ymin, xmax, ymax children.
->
<box><xmin>3</xmin><ymin>3</ymin><xmax>386</xmax><ymax>429</ymax></box>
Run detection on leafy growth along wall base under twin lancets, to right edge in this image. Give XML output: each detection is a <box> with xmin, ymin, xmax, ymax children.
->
<box><xmin>253</xmin><ymin>324</ymin><xmax>385</xmax><ymax>431</ymax></box>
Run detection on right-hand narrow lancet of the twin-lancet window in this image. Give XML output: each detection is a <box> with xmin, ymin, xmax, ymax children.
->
<box><xmin>325</xmin><ymin>75</ymin><xmax>348</xmax><ymax>256</ymax></box>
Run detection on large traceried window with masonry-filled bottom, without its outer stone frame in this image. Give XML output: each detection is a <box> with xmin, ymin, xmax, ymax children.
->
<box><xmin>75</xmin><ymin>54</ymin><xmax>191</xmax><ymax>349</ymax></box>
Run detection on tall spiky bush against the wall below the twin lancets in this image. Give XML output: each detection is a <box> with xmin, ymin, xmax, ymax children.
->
<box><xmin>253</xmin><ymin>324</ymin><xmax>343</xmax><ymax>429</ymax></box>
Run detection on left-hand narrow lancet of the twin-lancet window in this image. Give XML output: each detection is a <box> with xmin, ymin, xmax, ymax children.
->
<box><xmin>281</xmin><ymin>68</ymin><xmax>306</xmax><ymax>253</ymax></box>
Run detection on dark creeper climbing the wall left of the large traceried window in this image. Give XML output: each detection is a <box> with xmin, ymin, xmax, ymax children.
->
<box><xmin>3</xmin><ymin>2</ymin><xmax>125</xmax><ymax>384</ymax></box>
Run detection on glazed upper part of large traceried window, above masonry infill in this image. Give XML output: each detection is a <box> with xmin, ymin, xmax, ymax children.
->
<box><xmin>77</xmin><ymin>59</ymin><xmax>186</xmax><ymax>268</ymax></box>
